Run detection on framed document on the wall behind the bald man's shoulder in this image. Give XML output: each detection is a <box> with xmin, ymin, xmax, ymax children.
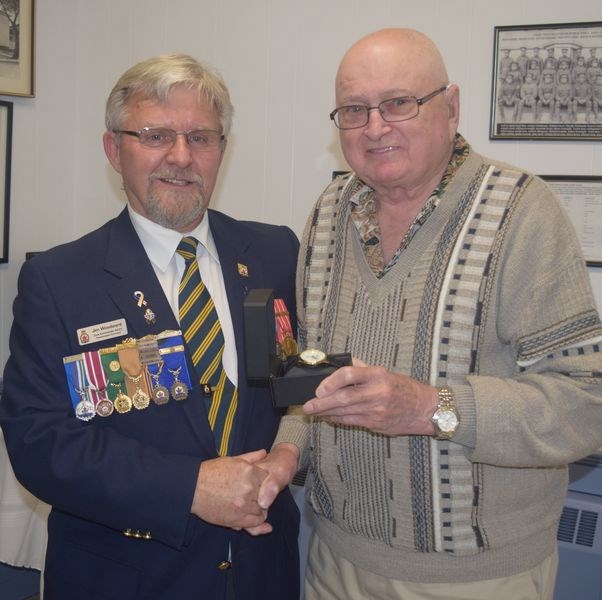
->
<box><xmin>540</xmin><ymin>175</ymin><xmax>602</xmax><ymax>267</ymax></box>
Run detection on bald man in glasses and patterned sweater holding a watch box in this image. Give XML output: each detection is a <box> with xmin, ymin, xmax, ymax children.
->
<box><xmin>253</xmin><ymin>29</ymin><xmax>602</xmax><ymax>600</ymax></box>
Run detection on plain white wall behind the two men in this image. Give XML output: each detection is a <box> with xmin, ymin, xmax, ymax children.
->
<box><xmin>0</xmin><ymin>0</ymin><xmax>602</xmax><ymax>366</ymax></box>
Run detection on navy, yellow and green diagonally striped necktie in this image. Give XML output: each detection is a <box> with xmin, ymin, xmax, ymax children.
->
<box><xmin>176</xmin><ymin>237</ymin><xmax>238</xmax><ymax>456</ymax></box>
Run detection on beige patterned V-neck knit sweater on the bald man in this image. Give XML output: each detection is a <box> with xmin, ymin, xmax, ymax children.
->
<box><xmin>275</xmin><ymin>151</ymin><xmax>602</xmax><ymax>582</ymax></box>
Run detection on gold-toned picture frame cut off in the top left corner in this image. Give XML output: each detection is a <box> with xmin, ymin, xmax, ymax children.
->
<box><xmin>0</xmin><ymin>0</ymin><xmax>35</xmax><ymax>98</ymax></box>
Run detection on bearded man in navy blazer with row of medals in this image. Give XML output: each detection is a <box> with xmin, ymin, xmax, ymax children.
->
<box><xmin>0</xmin><ymin>55</ymin><xmax>299</xmax><ymax>600</ymax></box>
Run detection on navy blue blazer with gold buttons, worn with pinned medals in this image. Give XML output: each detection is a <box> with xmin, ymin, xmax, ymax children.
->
<box><xmin>0</xmin><ymin>210</ymin><xmax>299</xmax><ymax>600</ymax></box>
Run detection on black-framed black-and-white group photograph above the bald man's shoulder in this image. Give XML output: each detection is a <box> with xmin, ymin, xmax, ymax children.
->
<box><xmin>489</xmin><ymin>21</ymin><xmax>602</xmax><ymax>141</ymax></box>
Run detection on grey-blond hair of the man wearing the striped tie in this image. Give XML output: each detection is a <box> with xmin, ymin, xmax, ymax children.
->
<box><xmin>105</xmin><ymin>54</ymin><xmax>234</xmax><ymax>137</ymax></box>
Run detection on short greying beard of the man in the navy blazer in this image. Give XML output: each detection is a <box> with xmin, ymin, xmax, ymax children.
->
<box><xmin>144</xmin><ymin>177</ymin><xmax>209</xmax><ymax>231</ymax></box>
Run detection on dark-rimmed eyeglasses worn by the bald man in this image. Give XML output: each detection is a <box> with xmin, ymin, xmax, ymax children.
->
<box><xmin>330</xmin><ymin>83</ymin><xmax>451</xmax><ymax>129</ymax></box>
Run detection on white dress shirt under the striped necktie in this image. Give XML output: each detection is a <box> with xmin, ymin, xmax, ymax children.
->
<box><xmin>128</xmin><ymin>205</ymin><xmax>238</xmax><ymax>385</ymax></box>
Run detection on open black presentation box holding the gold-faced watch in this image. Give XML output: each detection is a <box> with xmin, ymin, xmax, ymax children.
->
<box><xmin>243</xmin><ymin>289</ymin><xmax>351</xmax><ymax>408</ymax></box>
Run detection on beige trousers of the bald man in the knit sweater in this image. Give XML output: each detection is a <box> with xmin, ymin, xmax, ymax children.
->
<box><xmin>305</xmin><ymin>534</ymin><xmax>558</xmax><ymax>600</ymax></box>
